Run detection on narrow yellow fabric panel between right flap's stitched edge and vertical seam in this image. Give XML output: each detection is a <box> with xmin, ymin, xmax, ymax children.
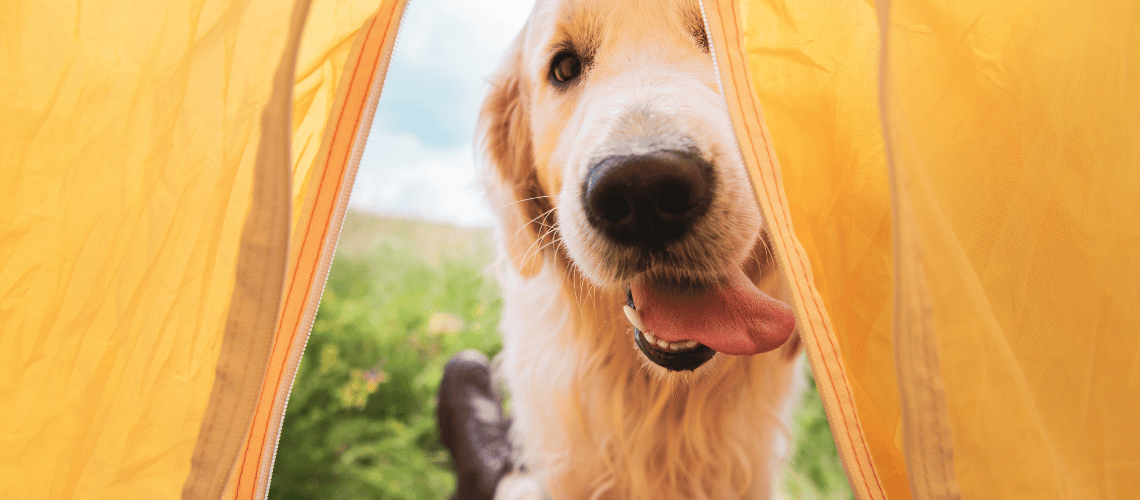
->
<box><xmin>728</xmin><ymin>0</ymin><xmax>909</xmax><ymax>499</ymax></box>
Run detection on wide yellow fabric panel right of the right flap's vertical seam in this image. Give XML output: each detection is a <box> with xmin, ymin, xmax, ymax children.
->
<box><xmin>884</xmin><ymin>0</ymin><xmax>1140</xmax><ymax>499</ymax></box>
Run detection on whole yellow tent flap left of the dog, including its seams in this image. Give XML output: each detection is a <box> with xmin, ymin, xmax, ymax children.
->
<box><xmin>0</xmin><ymin>0</ymin><xmax>404</xmax><ymax>499</ymax></box>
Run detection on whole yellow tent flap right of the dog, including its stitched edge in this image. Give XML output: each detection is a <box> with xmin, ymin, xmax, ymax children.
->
<box><xmin>705</xmin><ymin>0</ymin><xmax>1140</xmax><ymax>499</ymax></box>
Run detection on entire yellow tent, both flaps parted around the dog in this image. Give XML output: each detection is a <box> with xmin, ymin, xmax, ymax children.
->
<box><xmin>0</xmin><ymin>0</ymin><xmax>1140</xmax><ymax>499</ymax></box>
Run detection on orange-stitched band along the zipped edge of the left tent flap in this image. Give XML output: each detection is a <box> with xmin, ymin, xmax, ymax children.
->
<box><xmin>223</xmin><ymin>0</ymin><xmax>407</xmax><ymax>499</ymax></box>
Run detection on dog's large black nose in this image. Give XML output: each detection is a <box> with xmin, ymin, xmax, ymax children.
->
<box><xmin>583</xmin><ymin>150</ymin><xmax>714</xmax><ymax>248</ymax></box>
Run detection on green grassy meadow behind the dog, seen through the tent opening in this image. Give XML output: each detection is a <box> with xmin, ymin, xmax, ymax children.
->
<box><xmin>269</xmin><ymin>212</ymin><xmax>852</xmax><ymax>500</ymax></box>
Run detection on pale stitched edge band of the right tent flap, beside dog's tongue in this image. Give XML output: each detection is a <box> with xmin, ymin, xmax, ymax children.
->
<box><xmin>702</xmin><ymin>0</ymin><xmax>886</xmax><ymax>499</ymax></box>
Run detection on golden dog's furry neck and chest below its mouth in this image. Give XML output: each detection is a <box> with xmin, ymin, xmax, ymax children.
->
<box><xmin>500</xmin><ymin>260</ymin><xmax>799</xmax><ymax>500</ymax></box>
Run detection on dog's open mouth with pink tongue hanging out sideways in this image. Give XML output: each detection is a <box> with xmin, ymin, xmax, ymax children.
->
<box><xmin>625</xmin><ymin>267</ymin><xmax>796</xmax><ymax>371</ymax></box>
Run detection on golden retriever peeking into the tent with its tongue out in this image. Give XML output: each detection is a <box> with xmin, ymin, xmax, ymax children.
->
<box><xmin>480</xmin><ymin>0</ymin><xmax>801</xmax><ymax>500</ymax></box>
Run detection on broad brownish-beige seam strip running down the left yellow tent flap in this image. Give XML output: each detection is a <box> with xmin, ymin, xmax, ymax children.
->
<box><xmin>181</xmin><ymin>0</ymin><xmax>309</xmax><ymax>500</ymax></box>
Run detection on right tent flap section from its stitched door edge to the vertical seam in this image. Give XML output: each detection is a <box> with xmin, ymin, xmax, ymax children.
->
<box><xmin>703</xmin><ymin>1</ymin><xmax>907</xmax><ymax>499</ymax></box>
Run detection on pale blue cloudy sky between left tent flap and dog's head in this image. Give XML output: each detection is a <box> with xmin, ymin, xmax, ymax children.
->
<box><xmin>349</xmin><ymin>0</ymin><xmax>534</xmax><ymax>227</ymax></box>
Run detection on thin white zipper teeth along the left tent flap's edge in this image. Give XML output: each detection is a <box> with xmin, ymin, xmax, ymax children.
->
<box><xmin>261</xmin><ymin>0</ymin><xmax>412</xmax><ymax>500</ymax></box>
